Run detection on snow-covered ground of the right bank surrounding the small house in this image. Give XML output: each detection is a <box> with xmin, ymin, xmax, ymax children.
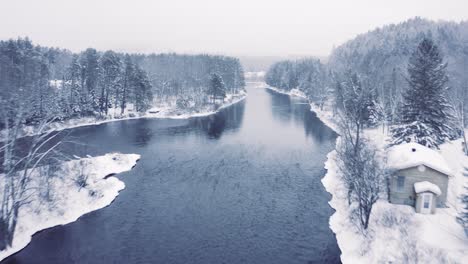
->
<box><xmin>268</xmin><ymin>84</ymin><xmax>468</xmax><ymax>263</ymax></box>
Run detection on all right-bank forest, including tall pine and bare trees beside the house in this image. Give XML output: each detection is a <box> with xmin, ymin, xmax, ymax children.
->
<box><xmin>265</xmin><ymin>18</ymin><xmax>468</xmax><ymax>235</ymax></box>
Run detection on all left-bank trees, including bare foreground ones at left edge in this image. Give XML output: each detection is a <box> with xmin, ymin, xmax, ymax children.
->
<box><xmin>0</xmin><ymin>38</ymin><xmax>245</xmax><ymax>251</ymax></box>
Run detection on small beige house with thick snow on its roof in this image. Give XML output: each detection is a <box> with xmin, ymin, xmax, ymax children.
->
<box><xmin>387</xmin><ymin>143</ymin><xmax>452</xmax><ymax>214</ymax></box>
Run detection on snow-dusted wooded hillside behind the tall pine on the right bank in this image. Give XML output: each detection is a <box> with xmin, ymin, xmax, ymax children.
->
<box><xmin>266</xmin><ymin>18</ymin><xmax>468</xmax><ymax>125</ymax></box>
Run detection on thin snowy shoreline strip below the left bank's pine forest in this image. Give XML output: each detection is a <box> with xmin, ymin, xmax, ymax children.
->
<box><xmin>5</xmin><ymin>92</ymin><xmax>247</xmax><ymax>137</ymax></box>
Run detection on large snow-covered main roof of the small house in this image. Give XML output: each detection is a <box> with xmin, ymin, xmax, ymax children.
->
<box><xmin>387</xmin><ymin>142</ymin><xmax>452</xmax><ymax>176</ymax></box>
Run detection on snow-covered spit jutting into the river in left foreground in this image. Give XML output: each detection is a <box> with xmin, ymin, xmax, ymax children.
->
<box><xmin>0</xmin><ymin>153</ymin><xmax>140</xmax><ymax>261</ymax></box>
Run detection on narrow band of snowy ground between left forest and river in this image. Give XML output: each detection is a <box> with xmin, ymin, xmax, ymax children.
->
<box><xmin>0</xmin><ymin>91</ymin><xmax>247</xmax><ymax>138</ymax></box>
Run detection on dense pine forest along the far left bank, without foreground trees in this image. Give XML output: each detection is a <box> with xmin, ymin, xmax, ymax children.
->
<box><xmin>0</xmin><ymin>38</ymin><xmax>245</xmax><ymax>127</ymax></box>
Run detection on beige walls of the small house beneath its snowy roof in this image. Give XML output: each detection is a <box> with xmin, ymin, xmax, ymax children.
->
<box><xmin>389</xmin><ymin>167</ymin><xmax>449</xmax><ymax>207</ymax></box>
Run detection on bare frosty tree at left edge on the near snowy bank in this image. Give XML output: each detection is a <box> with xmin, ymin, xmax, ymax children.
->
<box><xmin>0</xmin><ymin>102</ymin><xmax>61</xmax><ymax>250</ymax></box>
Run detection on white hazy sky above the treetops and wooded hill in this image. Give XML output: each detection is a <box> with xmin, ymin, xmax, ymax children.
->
<box><xmin>0</xmin><ymin>0</ymin><xmax>468</xmax><ymax>56</ymax></box>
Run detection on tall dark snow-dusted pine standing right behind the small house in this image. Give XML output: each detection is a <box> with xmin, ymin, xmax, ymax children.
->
<box><xmin>391</xmin><ymin>38</ymin><xmax>454</xmax><ymax>148</ymax></box>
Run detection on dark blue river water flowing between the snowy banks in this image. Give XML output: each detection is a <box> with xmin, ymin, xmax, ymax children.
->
<box><xmin>4</xmin><ymin>84</ymin><xmax>340</xmax><ymax>264</ymax></box>
